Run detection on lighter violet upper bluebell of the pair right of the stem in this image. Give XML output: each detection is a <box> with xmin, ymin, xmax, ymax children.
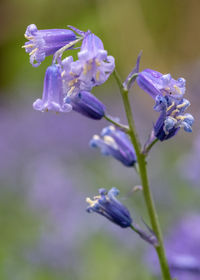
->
<box><xmin>136</xmin><ymin>69</ymin><xmax>186</xmax><ymax>99</ymax></box>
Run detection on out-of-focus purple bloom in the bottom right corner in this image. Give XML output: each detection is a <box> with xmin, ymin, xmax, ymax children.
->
<box><xmin>148</xmin><ymin>214</ymin><xmax>200</xmax><ymax>280</ymax></box>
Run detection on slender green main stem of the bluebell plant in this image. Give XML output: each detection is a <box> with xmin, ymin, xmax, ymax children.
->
<box><xmin>114</xmin><ymin>71</ymin><xmax>171</xmax><ymax>280</ymax></box>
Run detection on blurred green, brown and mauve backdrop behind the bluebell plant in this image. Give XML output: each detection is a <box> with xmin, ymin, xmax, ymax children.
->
<box><xmin>0</xmin><ymin>0</ymin><xmax>200</xmax><ymax>280</ymax></box>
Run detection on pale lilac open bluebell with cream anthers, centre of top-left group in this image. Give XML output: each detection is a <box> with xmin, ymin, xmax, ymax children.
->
<box><xmin>62</xmin><ymin>31</ymin><xmax>115</xmax><ymax>95</ymax></box>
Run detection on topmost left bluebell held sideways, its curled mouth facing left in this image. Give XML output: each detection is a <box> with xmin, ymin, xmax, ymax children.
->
<box><xmin>23</xmin><ymin>24</ymin><xmax>77</xmax><ymax>67</ymax></box>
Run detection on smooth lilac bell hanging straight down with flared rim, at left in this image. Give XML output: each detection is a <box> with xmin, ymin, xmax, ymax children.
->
<box><xmin>33</xmin><ymin>65</ymin><xmax>72</xmax><ymax>112</ymax></box>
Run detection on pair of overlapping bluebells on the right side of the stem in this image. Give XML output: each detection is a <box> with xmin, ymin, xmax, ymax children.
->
<box><xmin>136</xmin><ymin>69</ymin><xmax>194</xmax><ymax>141</ymax></box>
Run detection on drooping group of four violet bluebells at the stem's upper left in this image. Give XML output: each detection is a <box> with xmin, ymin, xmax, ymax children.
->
<box><xmin>23</xmin><ymin>24</ymin><xmax>115</xmax><ymax>119</ymax></box>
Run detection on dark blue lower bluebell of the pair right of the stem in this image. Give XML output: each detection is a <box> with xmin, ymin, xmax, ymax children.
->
<box><xmin>154</xmin><ymin>95</ymin><xmax>194</xmax><ymax>141</ymax></box>
